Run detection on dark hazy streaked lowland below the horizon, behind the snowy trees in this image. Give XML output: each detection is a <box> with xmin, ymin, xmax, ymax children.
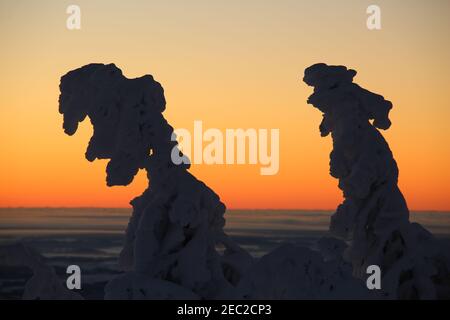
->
<box><xmin>0</xmin><ymin>208</ymin><xmax>450</xmax><ymax>299</ymax></box>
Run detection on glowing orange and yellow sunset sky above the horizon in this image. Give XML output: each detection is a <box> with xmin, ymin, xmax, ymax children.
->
<box><xmin>0</xmin><ymin>0</ymin><xmax>450</xmax><ymax>210</ymax></box>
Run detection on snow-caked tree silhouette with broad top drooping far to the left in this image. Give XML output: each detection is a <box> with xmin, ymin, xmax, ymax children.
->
<box><xmin>59</xmin><ymin>64</ymin><xmax>251</xmax><ymax>299</ymax></box>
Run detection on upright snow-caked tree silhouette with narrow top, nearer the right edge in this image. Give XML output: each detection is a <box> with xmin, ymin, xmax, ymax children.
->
<box><xmin>303</xmin><ymin>63</ymin><xmax>450</xmax><ymax>299</ymax></box>
